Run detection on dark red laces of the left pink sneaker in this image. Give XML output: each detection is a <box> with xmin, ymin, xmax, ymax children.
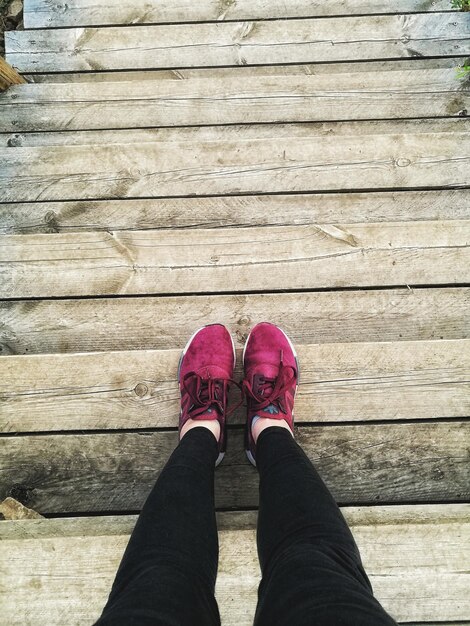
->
<box><xmin>183</xmin><ymin>372</ymin><xmax>243</xmax><ymax>419</ymax></box>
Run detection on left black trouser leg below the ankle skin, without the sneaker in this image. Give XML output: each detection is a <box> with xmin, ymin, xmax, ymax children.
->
<box><xmin>96</xmin><ymin>427</ymin><xmax>220</xmax><ymax>626</ymax></box>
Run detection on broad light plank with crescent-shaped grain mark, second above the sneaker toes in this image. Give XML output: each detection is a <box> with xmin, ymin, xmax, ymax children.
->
<box><xmin>0</xmin><ymin>220</ymin><xmax>470</xmax><ymax>298</ymax></box>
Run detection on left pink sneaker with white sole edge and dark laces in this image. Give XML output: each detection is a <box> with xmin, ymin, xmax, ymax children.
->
<box><xmin>178</xmin><ymin>324</ymin><xmax>236</xmax><ymax>465</ymax></box>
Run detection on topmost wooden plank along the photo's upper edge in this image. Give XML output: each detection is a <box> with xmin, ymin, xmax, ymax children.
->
<box><xmin>24</xmin><ymin>0</ymin><xmax>450</xmax><ymax>28</ymax></box>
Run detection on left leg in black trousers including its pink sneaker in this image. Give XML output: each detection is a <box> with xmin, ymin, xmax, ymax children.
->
<box><xmin>96</xmin><ymin>324</ymin><xmax>239</xmax><ymax>626</ymax></box>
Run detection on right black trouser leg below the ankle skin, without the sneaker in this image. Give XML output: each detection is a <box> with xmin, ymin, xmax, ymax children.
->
<box><xmin>255</xmin><ymin>426</ymin><xmax>395</xmax><ymax>626</ymax></box>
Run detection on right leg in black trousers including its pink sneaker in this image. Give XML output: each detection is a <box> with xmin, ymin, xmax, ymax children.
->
<box><xmin>244</xmin><ymin>323</ymin><xmax>395</xmax><ymax>626</ymax></box>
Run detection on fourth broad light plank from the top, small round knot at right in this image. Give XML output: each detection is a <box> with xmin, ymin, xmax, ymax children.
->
<box><xmin>0</xmin><ymin>120</ymin><xmax>470</xmax><ymax>202</ymax></box>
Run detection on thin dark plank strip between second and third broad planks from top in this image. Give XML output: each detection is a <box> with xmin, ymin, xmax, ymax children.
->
<box><xmin>24</xmin><ymin>57</ymin><xmax>463</xmax><ymax>84</ymax></box>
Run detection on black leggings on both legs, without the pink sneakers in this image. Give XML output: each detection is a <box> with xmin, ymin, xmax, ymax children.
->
<box><xmin>96</xmin><ymin>427</ymin><xmax>396</xmax><ymax>626</ymax></box>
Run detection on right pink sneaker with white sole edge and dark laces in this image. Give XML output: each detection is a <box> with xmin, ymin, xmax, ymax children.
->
<box><xmin>243</xmin><ymin>322</ymin><xmax>299</xmax><ymax>465</ymax></box>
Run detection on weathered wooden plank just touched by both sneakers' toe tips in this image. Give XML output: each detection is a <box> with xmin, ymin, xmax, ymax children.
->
<box><xmin>0</xmin><ymin>288</ymin><xmax>470</xmax><ymax>355</ymax></box>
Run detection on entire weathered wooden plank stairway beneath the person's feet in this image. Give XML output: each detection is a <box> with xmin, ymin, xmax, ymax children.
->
<box><xmin>0</xmin><ymin>0</ymin><xmax>470</xmax><ymax>626</ymax></box>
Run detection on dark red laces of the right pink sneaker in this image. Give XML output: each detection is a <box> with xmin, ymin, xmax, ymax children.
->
<box><xmin>242</xmin><ymin>350</ymin><xmax>296</xmax><ymax>414</ymax></box>
